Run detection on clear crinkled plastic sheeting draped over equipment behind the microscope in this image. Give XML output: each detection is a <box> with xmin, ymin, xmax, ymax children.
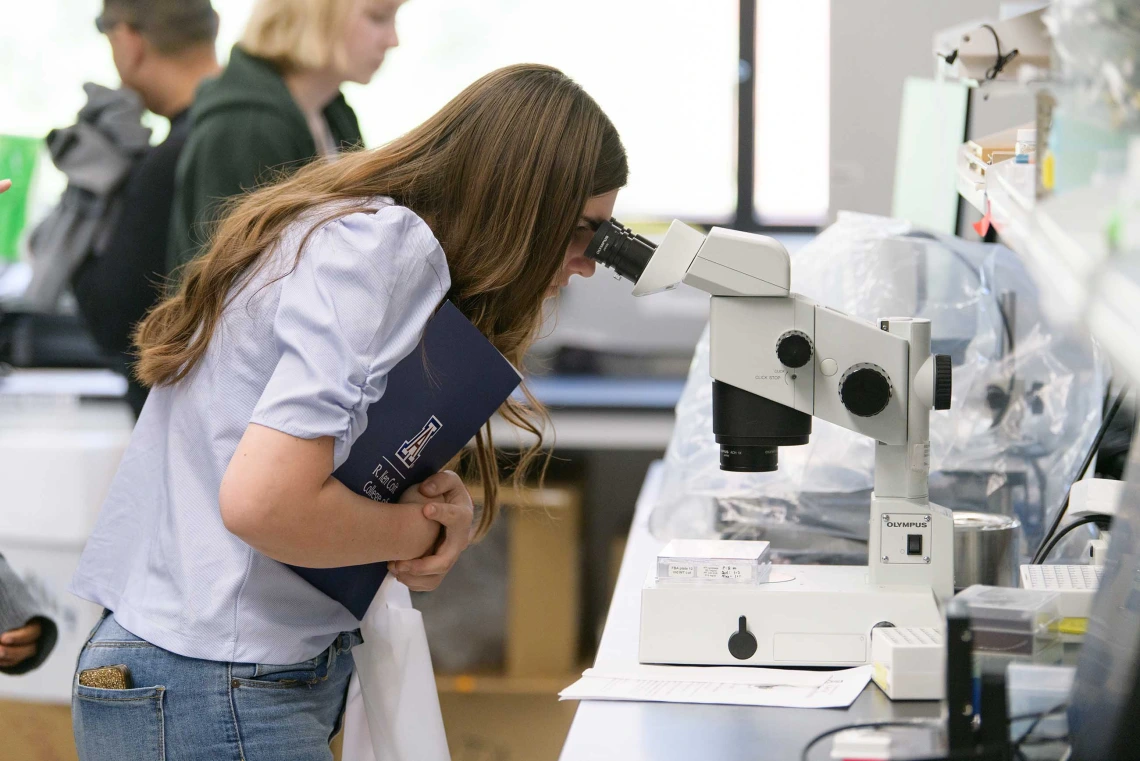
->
<box><xmin>651</xmin><ymin>213</ymin><xmax>1106</xmax><ymax>563</ymax></box>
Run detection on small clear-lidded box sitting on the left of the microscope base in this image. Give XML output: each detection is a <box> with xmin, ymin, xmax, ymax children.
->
<box><xmin>657</xmin><ymin>539</ymin><xmax>772</xmax><ymax>584</ymax></box>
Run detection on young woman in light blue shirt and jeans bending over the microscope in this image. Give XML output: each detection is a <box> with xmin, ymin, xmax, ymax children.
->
<box><xmin>73</xmin><ymin>65</ymin><xmax>627</xmax><ymax>761</ymax></box>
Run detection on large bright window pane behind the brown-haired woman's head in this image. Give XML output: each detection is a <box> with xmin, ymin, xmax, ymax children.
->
<box><xmin>349</xmin><ymin>0</ymin><xmax>738</xmax><ymax>219</ymax></box>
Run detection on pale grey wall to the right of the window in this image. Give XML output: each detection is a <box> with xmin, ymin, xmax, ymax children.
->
<box><xmin>830</xmin><ymin>0</ymin><xmax>1033</xmax><ymax>220</ymax></box>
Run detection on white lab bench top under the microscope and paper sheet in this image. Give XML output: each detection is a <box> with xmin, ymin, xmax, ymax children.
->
<box><xmin>561</xmin><ymin>463</ymin><xmax>941</xmax><ymax>761</ymax></box>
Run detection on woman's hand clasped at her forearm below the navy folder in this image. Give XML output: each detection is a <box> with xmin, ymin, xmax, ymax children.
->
<box><xmin>388</xmin><ymin>470</ymin><xmax>475</xmax><ymax>592</ymax></box>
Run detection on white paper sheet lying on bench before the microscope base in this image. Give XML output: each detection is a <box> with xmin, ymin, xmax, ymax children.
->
<box><xmin>559</xmin><ymin>665</ymin><xmax>871</xmax><ymax>709</ymax></box>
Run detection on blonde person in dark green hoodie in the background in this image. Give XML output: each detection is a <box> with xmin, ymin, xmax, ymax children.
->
<box><xmin>169</xmin><ymin>0</ymin><xmax>402</xmax><ymax>269</ymax></box>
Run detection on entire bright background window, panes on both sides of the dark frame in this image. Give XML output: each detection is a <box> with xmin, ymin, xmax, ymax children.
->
<box><xmin>0</xmin><ymin>0</ymin><xmax>828</xmax><ymax>223</ymax></box>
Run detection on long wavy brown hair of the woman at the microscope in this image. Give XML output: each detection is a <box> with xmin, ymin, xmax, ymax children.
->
<box><xmin>136</xmin><ymin>64</ymin><xmax>628</xmax><ymax>537</ymax></box>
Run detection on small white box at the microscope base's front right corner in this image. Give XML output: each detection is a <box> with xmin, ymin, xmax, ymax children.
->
<box><xmin>871</xmin><ymin>627</ymin><xmax>946</xmax><ymax>701</ymax></box>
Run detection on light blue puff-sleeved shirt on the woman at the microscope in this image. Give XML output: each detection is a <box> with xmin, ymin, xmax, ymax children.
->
<box><xmin>72</xmin><ymin>198</ymin><xmax>450</xmax><ymax>664</ymax></box>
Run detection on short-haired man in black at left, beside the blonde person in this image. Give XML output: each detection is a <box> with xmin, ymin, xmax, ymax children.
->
<box><xmin>72</xmin><ymin>0</ymin><xmax>221</xmax><ymax>416</ymax></box>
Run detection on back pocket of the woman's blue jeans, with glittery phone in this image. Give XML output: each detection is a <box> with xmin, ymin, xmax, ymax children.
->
<box><xmin>72</xmin><ymin>681</ymin><xmax>166</xmax><ymax>761</ymax></box>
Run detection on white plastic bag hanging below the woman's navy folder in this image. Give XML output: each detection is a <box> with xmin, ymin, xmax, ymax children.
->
<box><xmin>343</xmin><ymin>575</ymin><xmax>451</xmax><ymax>761</ymax></box>
